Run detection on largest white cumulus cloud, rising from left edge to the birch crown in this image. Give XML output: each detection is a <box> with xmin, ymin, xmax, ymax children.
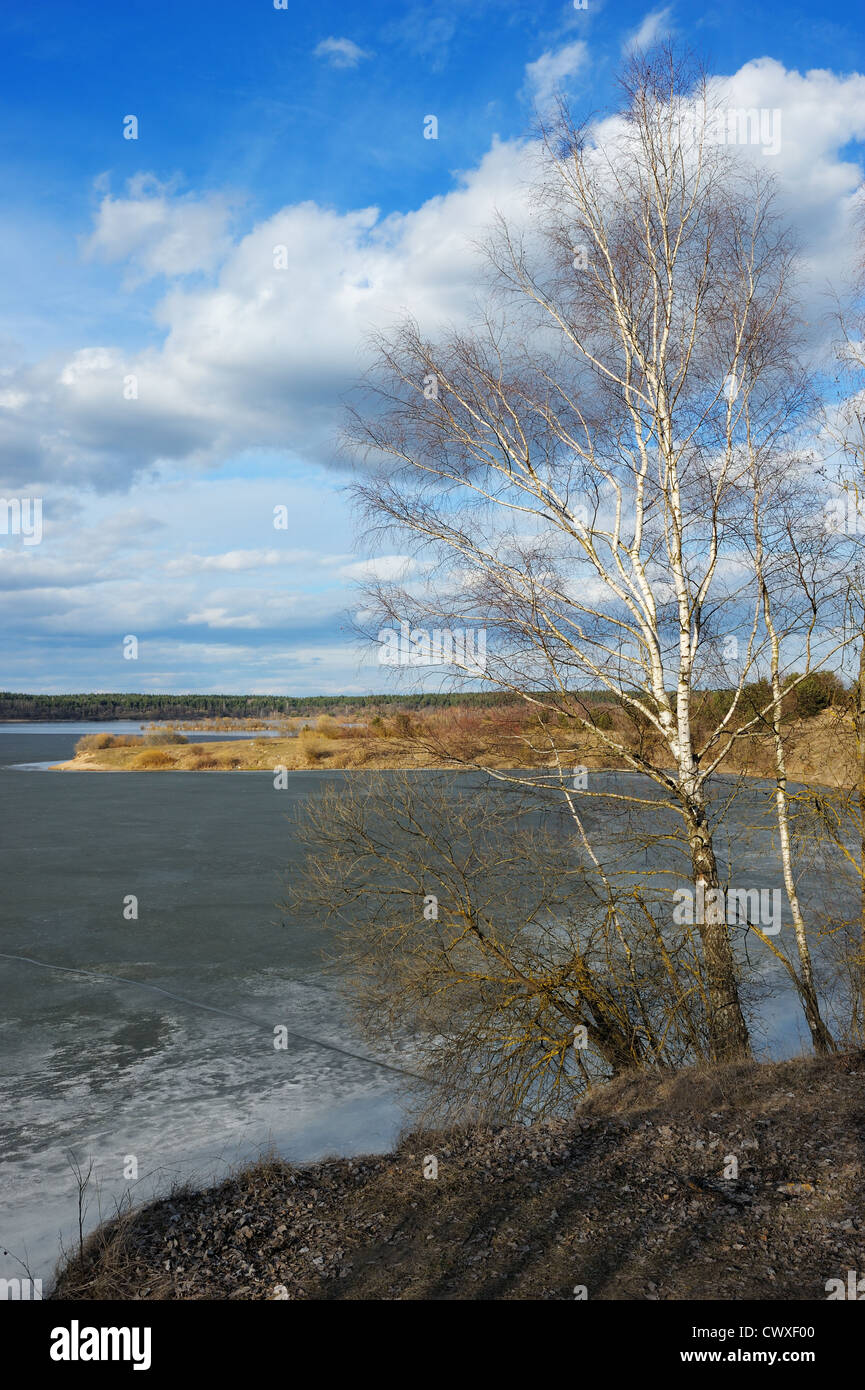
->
<box><xmin>0</xmin><ymin>135</ymin><xmax>539</xmax><ymax>489</ymax></box>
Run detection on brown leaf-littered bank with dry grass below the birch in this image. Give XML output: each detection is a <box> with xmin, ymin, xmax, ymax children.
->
<box><xmin>54</xmin><ymin>1052</ymin><xmax>865</xmax><ymax>1300</ymax></box>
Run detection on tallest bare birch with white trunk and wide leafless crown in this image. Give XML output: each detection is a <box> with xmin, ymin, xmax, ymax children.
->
<box><xmin>349</xmin><ymin>47</ymin><xmax>845</xmax><ymax>1059</ymax></box>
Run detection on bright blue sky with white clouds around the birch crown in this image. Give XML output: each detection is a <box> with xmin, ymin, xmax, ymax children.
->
<box><xmin>0</xmin><ymin>0</ymin><xmax>865</xmax><ymax>695</ymax></box>
